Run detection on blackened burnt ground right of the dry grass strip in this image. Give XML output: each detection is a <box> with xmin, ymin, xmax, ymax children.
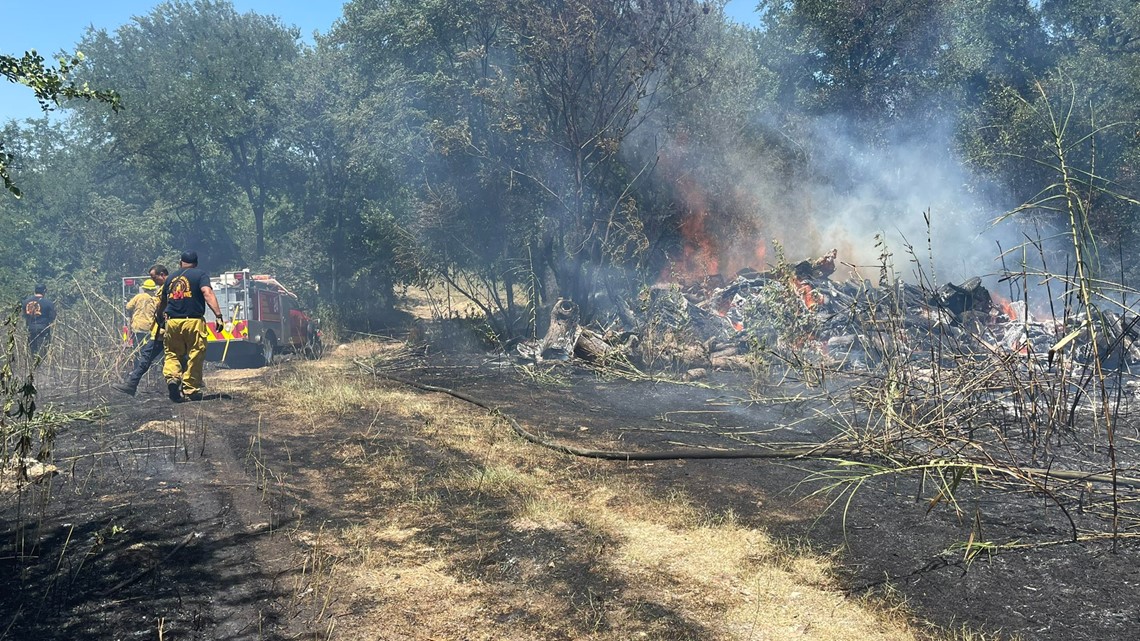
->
<box><xmin>409</xmin><ymin>353</ymin><xmax>1140</xmax><ymax>641</ymax></box>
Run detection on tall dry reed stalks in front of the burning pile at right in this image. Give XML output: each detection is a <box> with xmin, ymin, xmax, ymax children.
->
<box><xmin>756</xmin><ymin>79</ymin><xmax>1140</xmax><ymax>549</ymax></box>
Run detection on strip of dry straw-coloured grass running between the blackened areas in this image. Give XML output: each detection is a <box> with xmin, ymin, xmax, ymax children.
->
<box><xmin>221</xmin><ymin>343</ymin><xmax>964</xmax><ymax>640</ymax></box>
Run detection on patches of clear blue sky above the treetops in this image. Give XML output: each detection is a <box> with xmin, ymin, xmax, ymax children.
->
<box><xmin>0</xmin><ymin>0</ymin><xmax>757</xmax><ymax>122</ymax></box>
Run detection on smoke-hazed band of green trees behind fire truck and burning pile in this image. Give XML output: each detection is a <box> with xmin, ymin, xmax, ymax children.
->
<box><xmin>0</xmin><ymin>0</ymin><xmax>1140</xmax><ymax>332</ymax></box>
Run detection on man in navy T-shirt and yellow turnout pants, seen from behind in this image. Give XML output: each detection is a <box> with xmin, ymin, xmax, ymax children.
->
<box><xmin>155</xmin><ymin>251</ymin><xmax>225</xmax><ymax>403</ymax></box>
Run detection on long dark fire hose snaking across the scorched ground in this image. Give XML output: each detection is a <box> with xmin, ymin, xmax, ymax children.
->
<box><xmin>356</xmin><ymin>360</ymin><xmax>1140</xmax><ymax>488</ymax></box>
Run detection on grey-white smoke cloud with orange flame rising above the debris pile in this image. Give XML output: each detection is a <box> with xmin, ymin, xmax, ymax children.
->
<box><xmin>634</xmin><ymin>106</ymin><xmax>1020</xmax><ymax>283</ymax></box>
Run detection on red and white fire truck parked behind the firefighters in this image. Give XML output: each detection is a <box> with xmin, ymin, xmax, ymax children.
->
<box><xmin>123</xmin><ymin>269</ymin><xmax>324</xmax><ymax>367</ymax></box>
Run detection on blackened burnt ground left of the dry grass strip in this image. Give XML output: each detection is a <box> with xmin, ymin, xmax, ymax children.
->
<box><xmin>0</xmin><ymin>380</ymin><xmax>307</xmax><ymax>639</ymax></box>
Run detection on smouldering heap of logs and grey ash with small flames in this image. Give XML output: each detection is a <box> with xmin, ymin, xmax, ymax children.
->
<box><xmin>518</xmin><ymin>245</ymin><xmax>1140</xmax><ymax>378</ymax></box>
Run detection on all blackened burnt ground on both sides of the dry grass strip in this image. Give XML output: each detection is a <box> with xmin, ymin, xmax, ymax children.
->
<box><xmin>0</xmin><ymin>344</ymin><xmax>1140</xmax><ymax>641</ymax></box>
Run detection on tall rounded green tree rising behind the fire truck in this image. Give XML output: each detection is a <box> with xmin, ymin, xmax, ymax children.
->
<box><xmin>70</xmin><ymin>0</ymin><xmax>300</xmax><ymax>263</ymax></box>
